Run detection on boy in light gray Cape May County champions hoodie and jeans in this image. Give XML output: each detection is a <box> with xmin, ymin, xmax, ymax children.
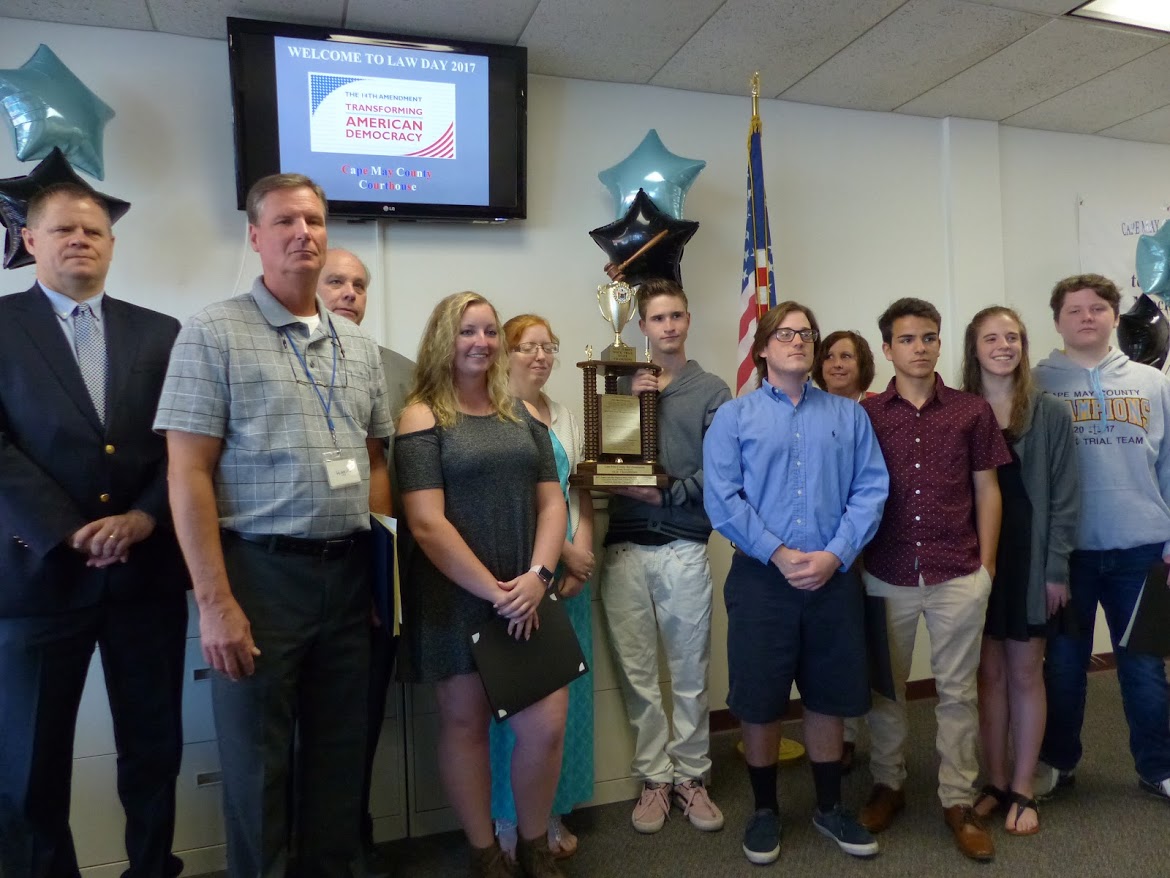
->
<box><xmin>1035</xmin><ymin>274</ymin><xmax>1170</xmax><ymax>800</ymax></box>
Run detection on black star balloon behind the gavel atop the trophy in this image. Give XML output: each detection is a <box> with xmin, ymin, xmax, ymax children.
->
<box><xmin>589</xmin><ymin>190</ymin><xmax>698</xmax><ymax>284</ymax></box>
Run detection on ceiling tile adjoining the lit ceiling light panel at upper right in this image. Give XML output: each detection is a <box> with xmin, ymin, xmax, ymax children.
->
<box><xmin>897</xmin><ymin>19</ymin><xmax>1168</xmax><ymax>121</ymax></box>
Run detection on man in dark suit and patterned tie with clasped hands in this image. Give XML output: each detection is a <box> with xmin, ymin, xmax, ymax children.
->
<box><xmin>0</xmin><ymin>184</ymin><xmax>187</xmax><ymax>878</ymax></box>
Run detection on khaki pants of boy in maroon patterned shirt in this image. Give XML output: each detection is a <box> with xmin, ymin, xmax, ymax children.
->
<box><xmin>862</xmin><ymin>567</ymin><xmax>991</xmax><ymax>808</ymax></box>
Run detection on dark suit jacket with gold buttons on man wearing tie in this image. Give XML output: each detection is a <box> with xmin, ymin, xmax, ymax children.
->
<box><xmin>0</xmin><ymin>286</ymin><xmax>187</xmax><ymax>617</ymax></box>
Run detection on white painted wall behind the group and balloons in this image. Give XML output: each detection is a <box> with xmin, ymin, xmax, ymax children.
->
<box><xmin>0</xmin><ymin>19</ymin><xmax>1141</xmax><ymax>725</ymax></box>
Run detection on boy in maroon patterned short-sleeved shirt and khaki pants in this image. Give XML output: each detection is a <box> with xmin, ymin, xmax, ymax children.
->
<box><xmin>861</xmin><ymin>299</ymin><xmax>1011</xmax><ymax>860</ymax></box>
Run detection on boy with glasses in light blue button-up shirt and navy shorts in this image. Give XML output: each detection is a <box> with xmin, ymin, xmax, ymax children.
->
<box><xmin>703</xmin><ymin>302</ymin><xmax>889</xmax><ymax>864</ymax></box>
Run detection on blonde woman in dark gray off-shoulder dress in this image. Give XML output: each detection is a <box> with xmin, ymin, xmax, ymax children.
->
<box><xmin>394</xmin><ymin>293</ymin><xmax>569</xmax><ymax>878</ymax></box>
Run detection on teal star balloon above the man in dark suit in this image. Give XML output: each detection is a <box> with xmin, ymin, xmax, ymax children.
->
<box><xmin>0</xmin><ymin>43</ymin><xmax>113</xmax><ymax>180</ymax></box>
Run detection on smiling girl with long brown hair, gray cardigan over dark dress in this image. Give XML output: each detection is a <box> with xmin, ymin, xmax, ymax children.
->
<box><xmin>963</xmin><ymin>306</ymin><xmax>1080</xmax><ymax>836</ymax></box>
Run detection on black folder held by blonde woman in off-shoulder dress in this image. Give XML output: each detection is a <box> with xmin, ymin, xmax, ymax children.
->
<box><xmin>472</xmin><ymin>590</ymin><xmax>589</xmax><ymax>722</ymax></box>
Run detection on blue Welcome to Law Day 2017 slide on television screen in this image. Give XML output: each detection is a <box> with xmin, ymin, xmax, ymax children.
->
<box><xmin>275</xmin><ymin>36</ymin><xmax>489</xmax><ymax>205</ymax></box>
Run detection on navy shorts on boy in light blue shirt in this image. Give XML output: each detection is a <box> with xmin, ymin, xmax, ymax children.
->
<box><xmin>723</xmin><ymin>551</ymin><xmax>869</xmax><ymax>725</ymax></box>
